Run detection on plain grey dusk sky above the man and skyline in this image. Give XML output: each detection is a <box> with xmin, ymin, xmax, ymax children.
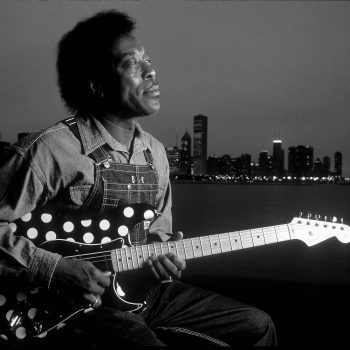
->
<box><xmin>0</xmin><ymin>0</ymin><xmax>350</xmax><ymax>176</ymax></box>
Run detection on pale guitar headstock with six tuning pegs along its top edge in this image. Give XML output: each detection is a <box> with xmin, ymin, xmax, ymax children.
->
<box><xmin>290</xmin><ymin>214</ymin><xmax>350</xmax><ymax>246</ymax></box>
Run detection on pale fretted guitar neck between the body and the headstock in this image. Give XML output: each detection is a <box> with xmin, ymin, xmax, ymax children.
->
<box><xmin>111</xmin><ymin>225</ymin><xmax>294</xmax><ymax>272</ymax></box>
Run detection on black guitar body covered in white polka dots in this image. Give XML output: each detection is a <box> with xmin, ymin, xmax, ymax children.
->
<box><xmin>0</xmin><ymin>204</ymin><xmax>157</xmax><ymax>343</ymax></box>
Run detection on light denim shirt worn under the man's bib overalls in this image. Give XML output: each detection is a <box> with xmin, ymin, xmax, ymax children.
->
<box><xmin>0</xmin><ymin>116</ymin><xmax>172</xmax><ymax>286</ymax></box>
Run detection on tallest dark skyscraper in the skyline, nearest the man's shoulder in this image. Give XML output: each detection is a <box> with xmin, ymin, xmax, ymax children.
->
<box><xmin>193</xmin><ymin>114</ymin><xmax>208</xmax><ymax>175</ymax></box>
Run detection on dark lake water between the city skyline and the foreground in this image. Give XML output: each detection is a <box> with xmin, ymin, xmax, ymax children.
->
<box><xmin>172</xmin><ymin>183</ymin><xmax>350</xmax><ymax>286</ymax></box>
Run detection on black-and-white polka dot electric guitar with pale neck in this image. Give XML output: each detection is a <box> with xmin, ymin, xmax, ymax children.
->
<box><xmin>0</xmin><ymin>204</ymin><xmax>350</xmax><ymax>342</ymax></box>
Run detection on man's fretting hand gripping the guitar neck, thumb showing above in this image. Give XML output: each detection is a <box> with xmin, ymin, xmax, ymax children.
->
<box><xmin>147</xmin><ymin>231</ymin><xmax>186</xmax><ymax>280</ymax></box>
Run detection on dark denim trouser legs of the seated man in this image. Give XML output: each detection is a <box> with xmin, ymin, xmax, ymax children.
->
<box><xmin>34</xmin><ymin>281</ymin><xmax>277</xmax><ymax>347</ymax></box>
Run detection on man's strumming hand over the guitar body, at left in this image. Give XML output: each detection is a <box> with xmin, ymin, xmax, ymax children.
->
<box><xmin>51</xmin><ymin>258</ymin><xmax>111</xmax><ymax>308</ymax></box>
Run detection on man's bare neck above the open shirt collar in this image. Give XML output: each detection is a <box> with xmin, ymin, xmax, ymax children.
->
<box><xmin>99</xmin><ymin>114</ymin><xmax>137</xmax><ymax>151</ymax></box>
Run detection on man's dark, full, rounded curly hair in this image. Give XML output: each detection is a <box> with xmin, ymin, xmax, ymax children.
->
<box><xmin>56</xmin><ymin>10</ymin><xmax>136</xmax><ymax>113</ymax></box>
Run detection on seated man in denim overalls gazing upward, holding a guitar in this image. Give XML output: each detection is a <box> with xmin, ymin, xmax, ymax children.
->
<box><xmin>0</xmin><ymin>11</ymin><xmax>276</xmax><ymax>345</ymax></box>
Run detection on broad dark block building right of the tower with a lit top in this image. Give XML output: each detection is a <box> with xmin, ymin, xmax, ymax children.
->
<box><xmin>288</xmin><ymin>145</ymin><xmax>314</xmax><ymax>176</ymax></box>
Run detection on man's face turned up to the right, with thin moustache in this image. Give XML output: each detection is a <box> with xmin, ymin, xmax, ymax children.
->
<box><xmin>103</xmin><ymin>36</ymin><xmax>160</xmax><ymax>118</ymax></box>
